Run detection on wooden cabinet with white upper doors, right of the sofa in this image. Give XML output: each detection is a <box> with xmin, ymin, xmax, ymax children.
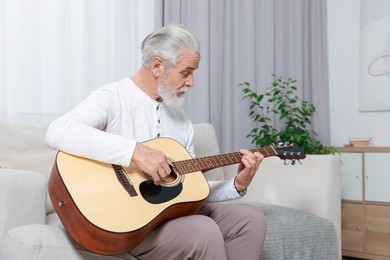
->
<box><xmin>339</xmin><ymin>147</ymin><xmax>390</xmax><ymax>259</ymax></box>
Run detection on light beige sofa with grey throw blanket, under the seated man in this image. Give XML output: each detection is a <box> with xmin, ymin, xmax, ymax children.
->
<box><xmin>0</xmin><ymin>123</ymin><xmax>341</xmax><ymax>260</ymax></box>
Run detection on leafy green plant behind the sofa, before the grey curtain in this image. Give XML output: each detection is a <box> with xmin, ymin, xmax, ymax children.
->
<box><xmin>239</xmin><ymin>74</ymin><xmax>337</xmax><ymax>154</ymax></box>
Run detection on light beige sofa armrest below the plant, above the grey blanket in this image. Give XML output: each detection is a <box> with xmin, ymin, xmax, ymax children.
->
<box><xmin>225</xmin><ymin>155</ymin><xmax>341</xmax><ymax>258</ymax></box>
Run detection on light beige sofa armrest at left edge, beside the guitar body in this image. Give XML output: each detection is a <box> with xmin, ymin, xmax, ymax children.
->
<box><xmin>0</xmin><ymin>169</ymin><xmax>47</xmax><ymax>241</ymax></box>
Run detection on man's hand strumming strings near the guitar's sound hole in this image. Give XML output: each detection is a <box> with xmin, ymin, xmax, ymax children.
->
<box><xmin>132</xmin><ymin>143</ymin><xmax>171</xmax><ymax>185</ymax></box>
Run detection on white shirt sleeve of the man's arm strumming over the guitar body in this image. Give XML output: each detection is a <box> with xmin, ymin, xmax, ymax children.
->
<box><xmin>46</xmin><ymin>88</ymin><xmax>136</xmax><ymax>166</ymax></box>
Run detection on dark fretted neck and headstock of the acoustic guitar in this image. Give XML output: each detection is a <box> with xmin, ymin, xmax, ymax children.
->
<box><xmin>172</xmin><ymin>146</ymin><xmax>277</xmax><ymax>174</ymax></box>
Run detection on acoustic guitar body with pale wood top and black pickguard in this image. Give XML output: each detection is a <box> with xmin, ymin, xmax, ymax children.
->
<box><xmin>48</xmin><ymin>138</ymin><xmax>209</xmax><ymax>255</ymax></box>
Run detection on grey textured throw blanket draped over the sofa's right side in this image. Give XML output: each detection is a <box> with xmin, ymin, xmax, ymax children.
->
<box><xmin>253</xmin><ymin>203</ymin><xmax>339</xmax><ymax>260</ymax></box>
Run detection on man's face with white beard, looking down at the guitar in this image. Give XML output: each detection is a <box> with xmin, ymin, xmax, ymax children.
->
<box><xmin>157</xmin><ymin>52</ymin><xmax>200</xmax><ymax>107</ymax></box>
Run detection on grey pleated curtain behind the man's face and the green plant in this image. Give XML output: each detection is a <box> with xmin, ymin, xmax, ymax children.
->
<box><xmin>159</xmin><ymin>0</ymin><xmax>329</xmax><ymax>152</ymax></box>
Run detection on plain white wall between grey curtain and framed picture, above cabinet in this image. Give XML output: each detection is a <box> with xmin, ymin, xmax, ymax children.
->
<box><xmin>328</xmin><ymin>0</ymin><xmax>390</xmax><ymax>146</ymax></box>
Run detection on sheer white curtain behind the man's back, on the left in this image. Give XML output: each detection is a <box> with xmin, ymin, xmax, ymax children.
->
<box><xmin>0</xmin><ymin>0</ymin><xmax>154</xmax><ymax>122</ymax></box>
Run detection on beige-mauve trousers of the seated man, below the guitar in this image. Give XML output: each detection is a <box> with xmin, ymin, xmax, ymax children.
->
<box><xmin>130</xmin><ymin>203</ymin><xmax>266</xmax><ymax>260</ymax></box>
